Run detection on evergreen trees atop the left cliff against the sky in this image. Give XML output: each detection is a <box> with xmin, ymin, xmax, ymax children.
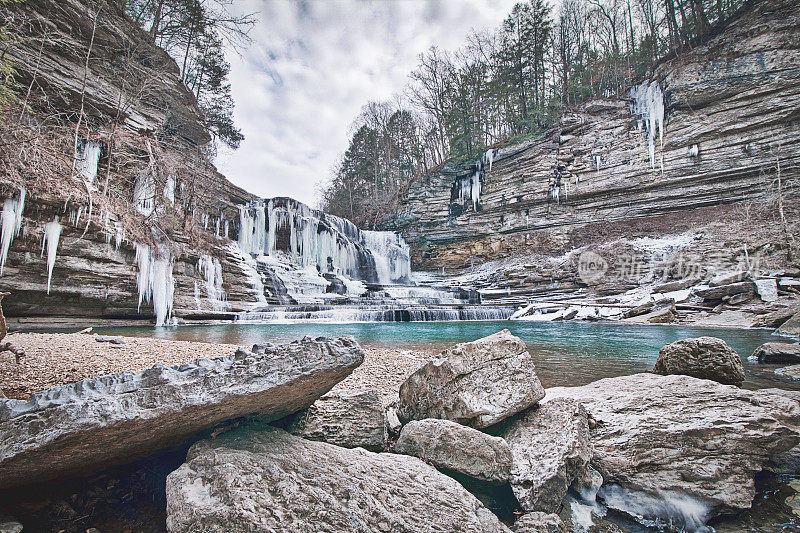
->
<box><xmin>125</xmin><ymin>0</ymin><xmax>255</xmax><ymax>148</ymax></box>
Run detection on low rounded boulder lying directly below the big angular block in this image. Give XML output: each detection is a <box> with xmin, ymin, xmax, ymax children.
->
<box><xmin>393</xmin><ymin>418</ymin><xmax>512</xmax><ymax>484</ymax></box>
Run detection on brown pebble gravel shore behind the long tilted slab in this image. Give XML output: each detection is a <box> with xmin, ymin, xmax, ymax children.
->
<box><xmin>0</xmin><ymin>333</ymin><xmax>434</xmax><ymax>402</ymax></box>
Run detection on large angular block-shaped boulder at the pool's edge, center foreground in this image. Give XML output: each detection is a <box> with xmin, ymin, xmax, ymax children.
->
<box><xmin>399</xmin><ymin>329</ymin><xmax>544</xmax><ymax>428</ymax></box>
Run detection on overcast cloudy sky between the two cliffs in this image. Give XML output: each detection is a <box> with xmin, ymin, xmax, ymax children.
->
<box><xmin>212</xmin><ymin>0</ymin><xmax>516</xmax><ymax>205</ymax></box>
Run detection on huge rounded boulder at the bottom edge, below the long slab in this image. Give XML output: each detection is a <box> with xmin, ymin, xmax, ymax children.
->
<box><xmin>167</xmin><ymin>426</ymin><xmax>508</xmax><ymax>533</ymax></box>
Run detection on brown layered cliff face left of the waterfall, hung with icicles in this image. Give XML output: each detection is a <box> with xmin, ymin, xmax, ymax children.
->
<box><xmin>0</xmin><ymin>0</ymin><xmax>256</xmax><ymax>326</ymax></box>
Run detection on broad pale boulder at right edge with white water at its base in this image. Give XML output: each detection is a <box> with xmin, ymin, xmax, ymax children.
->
<box><xmin>544</xmin><ymin>374</ymin><xmax>800</xmax><ymax>525</ymax></box>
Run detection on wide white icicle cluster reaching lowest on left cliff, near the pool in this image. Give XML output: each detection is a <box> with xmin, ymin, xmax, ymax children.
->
<box><xmin>135</xmin><ymin>243</ymin><xmax>175</xmax><ymax>326</ymax></box>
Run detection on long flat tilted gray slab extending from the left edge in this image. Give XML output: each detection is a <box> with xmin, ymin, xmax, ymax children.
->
<box><xmin>0</xmin><ymin>337</ymin><xmax>364</xmax><ymax>488</ymax></box>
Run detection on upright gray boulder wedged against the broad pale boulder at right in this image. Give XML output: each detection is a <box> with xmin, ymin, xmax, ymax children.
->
<box><xmin>503</xmin><ymin>399</ymin><xmax>592</xmax><ymax>513</ymax></box>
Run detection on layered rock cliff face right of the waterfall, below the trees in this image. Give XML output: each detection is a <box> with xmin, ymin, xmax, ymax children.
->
<box><xmin>390</xmin><ymin>0</ymin><xmax>800</xmax><ymax>274</ymax></box>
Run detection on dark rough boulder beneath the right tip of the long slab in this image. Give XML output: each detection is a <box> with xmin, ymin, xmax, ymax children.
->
<box><xmin>288</xmin><ymin>389</ymin><xmax>388</xmax><ymax>452</ymax></box>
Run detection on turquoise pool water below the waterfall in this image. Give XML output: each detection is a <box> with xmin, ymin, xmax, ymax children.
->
<box><xmin>101</xmin><ymin>321</ymin><xmax>800</xmax><ymax>389</ymax></box>
